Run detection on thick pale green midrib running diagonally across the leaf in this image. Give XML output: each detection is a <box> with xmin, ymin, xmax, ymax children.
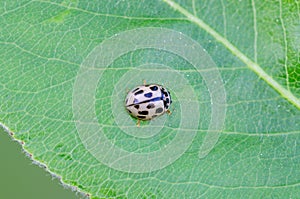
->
<box><xmin>163</xmin><ymin>0</ymin><xmax>300</xmax><ymax>109</ymax></box>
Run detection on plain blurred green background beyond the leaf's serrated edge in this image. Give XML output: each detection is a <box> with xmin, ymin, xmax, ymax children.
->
<box><xmin>0</xmin><ymin>127</ymin><xmax>82</xmax><ymax>199</ymax></box>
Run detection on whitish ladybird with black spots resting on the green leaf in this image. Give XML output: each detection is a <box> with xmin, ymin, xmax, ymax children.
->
<box><xmin>125</xmin><ymin>84</ymin><xmax>172</xmax><ymax>120</ymax></box>
